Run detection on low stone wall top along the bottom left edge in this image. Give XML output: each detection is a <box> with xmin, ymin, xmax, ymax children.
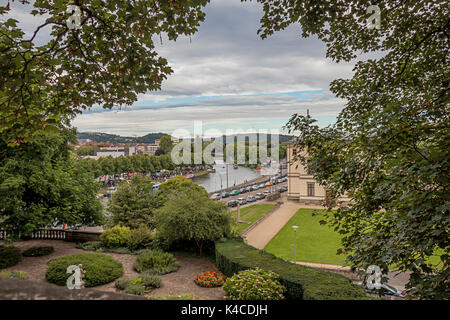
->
<box><xmin>0</xmin><ymin>277</ymin><xmax>145</xmax><ymax>300</ymax></box>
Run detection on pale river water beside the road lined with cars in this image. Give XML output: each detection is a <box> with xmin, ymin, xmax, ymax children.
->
<box><xmin>193</xmin><ymin>163</ymin><xmax>260</xmax><ymax>192</ymax></box>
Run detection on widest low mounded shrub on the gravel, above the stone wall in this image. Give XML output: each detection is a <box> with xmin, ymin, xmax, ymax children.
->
<box><xmin>45</xmin><ymin>253</ymin><xmax>123</xmax><ymax>287</ymax></box>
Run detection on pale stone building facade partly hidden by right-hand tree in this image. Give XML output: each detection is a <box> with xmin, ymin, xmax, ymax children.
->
<box><xmin>287</xmin><ymin>143</ymin><xmax>350</xmax><ymax>204</ymax></box>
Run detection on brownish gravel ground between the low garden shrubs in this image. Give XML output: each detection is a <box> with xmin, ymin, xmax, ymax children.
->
<box><xmin>0</xmin><ymin>240</ymin><xmax>224</xmax><ymax>300</ymax></box>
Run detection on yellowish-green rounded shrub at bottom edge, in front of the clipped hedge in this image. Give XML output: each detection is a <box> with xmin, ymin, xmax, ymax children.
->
<box><xmin>223</xmin><ymin>268</ymin><xmax>285</xmax><ymax>300</ymax></box>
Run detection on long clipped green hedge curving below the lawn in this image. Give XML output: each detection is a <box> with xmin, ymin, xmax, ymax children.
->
<box><xmin>216</xmin><ymin>239</ymin><xmax>367</xmax><ymax>300</ymax></box>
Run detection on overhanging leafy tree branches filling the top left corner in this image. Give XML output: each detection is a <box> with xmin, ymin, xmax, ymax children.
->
<box><xmin>0</xmin><ymin>0</ymin><xmax>208</xmax><ymax>143</ymax></box>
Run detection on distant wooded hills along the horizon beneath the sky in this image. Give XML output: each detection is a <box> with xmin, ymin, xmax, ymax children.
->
<box><xmin>77</xmin><ymin>132</ymin><xmax>292</xmax><ymax>143</ymax></box>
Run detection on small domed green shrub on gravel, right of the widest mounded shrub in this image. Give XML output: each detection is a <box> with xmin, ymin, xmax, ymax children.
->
<box><xmin>133</xmin><ymin>250</ymin><xmax>180</xmax><ymax>274</ymax></box>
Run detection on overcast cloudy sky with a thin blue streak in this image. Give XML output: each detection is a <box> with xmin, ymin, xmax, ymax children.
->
<box><xmin>4</xmin><ymin>0</ymin><xmax>353</xmax><ymax>136</ymax></box>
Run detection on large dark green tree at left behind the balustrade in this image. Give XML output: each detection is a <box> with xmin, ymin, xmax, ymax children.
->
<box><xmin>0</xmin><ymin>129</ymin><xmax>104</xmax><ymax>235</ymax></box>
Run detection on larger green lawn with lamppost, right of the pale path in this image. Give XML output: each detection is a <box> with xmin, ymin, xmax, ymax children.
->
<box><xmin>264</xmin><ymin>209</ymin><xmax>345</xmax><ymax>265</ymax></box>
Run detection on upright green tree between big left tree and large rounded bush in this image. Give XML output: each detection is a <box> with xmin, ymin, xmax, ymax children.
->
<box><xmin>108</xmin><ymin>175</ymin><xmax>161</xmax><ymax>229</ymax></box>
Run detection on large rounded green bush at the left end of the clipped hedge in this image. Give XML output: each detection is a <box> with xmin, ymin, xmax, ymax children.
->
<box><xmin>155</xmin><ymin>186</ymin><xmax>231</xmax><ymax>255</ymax></box>
